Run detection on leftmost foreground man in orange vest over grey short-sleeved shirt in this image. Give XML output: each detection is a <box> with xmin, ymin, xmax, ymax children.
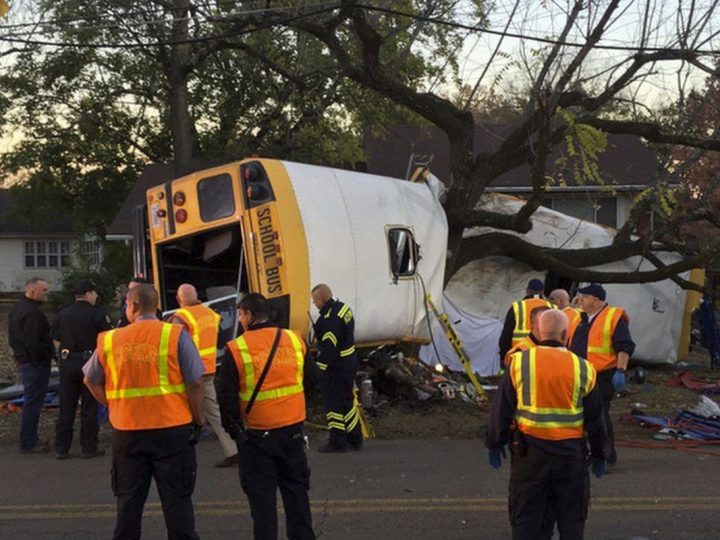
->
<box><xmin>83</xmin><ymin>284</ymin><xmax>204</xmax><ymax>540</ymax></box>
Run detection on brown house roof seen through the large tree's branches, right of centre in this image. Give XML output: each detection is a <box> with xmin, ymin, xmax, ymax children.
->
<box><xmin>364</xmin><ymin>124</ymin><xmax>659</xmax><ymax>191</ymax></box>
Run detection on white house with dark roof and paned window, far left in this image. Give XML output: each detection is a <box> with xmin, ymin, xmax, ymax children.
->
<box><xmin>0</xmin><ymin>189</ymin><xmax>102</xmax><ymax>293</ymax></box>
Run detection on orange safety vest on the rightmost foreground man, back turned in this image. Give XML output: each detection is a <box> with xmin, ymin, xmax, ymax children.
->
<box><xmin>510</xmin><ymin>345</ymin><xmax>597</xmax><ymax>441</ymax></box>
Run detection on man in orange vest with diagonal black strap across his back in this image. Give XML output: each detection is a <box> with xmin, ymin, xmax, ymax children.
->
<box><xmin>218</xmin><ymin>293</ymin><xmax>315</xmax><ymax>540</ymax></box>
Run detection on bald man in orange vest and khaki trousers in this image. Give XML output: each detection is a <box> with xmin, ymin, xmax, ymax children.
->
<box><xmin>170</xmin><ymin>283</ymin><xmax>239</xmax><ymax>467</ymax></box>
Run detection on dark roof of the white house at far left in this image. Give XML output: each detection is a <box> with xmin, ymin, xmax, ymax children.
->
<box><xmin>0</xmin><ymin>189</ymin><xmax>73</xmax><ymax>237</ymax></box>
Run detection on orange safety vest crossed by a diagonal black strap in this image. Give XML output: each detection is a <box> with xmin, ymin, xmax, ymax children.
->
<box><xmin>228</xmin><ymin>328</ymin><xmax>305</xmax><ymax>430</ymax></box>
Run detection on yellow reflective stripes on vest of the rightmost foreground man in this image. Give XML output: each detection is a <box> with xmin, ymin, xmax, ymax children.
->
<box><xmin>510</xmin><ymin>348</ymin><xmax>594</xmax><ymax>432</ymax></box>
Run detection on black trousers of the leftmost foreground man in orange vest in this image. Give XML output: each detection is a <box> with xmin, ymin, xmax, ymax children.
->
<box><xmin>112</xmin><ymin>425</ymin><xmax>198</xmax><ymax>540</ymax></box>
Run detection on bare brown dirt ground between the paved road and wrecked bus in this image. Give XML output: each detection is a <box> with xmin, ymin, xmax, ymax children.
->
<box><xmin>0</xmin><ymin>306</ymin><xmax>720</xmax><ymax>446</ymax></box>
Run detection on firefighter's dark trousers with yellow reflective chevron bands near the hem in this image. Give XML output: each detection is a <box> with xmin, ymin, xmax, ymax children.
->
<box><xmin>321</xmin><ymin>364</ymin><xmax>363</xmax><ymax>448</ymax></box>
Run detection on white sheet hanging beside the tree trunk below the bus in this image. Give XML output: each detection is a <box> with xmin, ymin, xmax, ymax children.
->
<box><xmin>420</xmin><ymin>295</ymin><xmax>502</xmax><ymax>376</ymax></box>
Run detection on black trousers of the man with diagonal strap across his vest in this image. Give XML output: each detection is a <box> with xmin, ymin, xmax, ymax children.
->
<box><xmin>238</xmin><ymin>424</ymin><xmax>315</xmax><ymax>540</ymax></box>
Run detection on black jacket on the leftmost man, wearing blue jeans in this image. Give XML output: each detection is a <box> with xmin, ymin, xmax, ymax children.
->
<box><xmin>8</xmin><ymin>296</ymin><xmax>53</xmax><ymax>364</ymax></box>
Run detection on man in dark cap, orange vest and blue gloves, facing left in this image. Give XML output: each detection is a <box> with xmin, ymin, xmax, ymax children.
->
<box><xmin>568</xmin><ymin>283</ymin><xmax>635</xmax><ymax>465</ymax></box>
